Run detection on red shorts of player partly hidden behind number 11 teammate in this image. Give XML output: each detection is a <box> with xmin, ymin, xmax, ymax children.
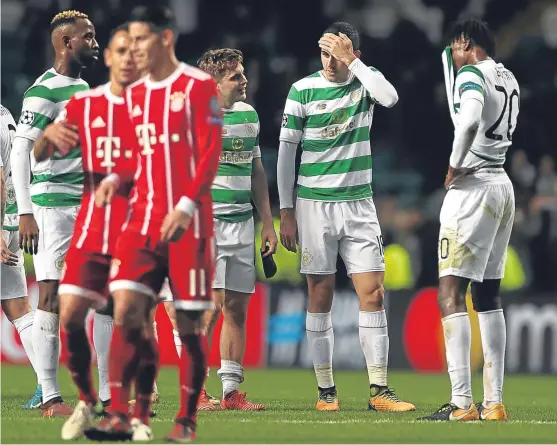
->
<box><xmin>58</xmin><ymin>247</ymin><xmax>112</xmax><ymax>309</ymax></box>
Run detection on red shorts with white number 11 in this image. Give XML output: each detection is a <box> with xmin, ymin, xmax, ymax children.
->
<box><xmin>109</xmin><ymin>230</ymin><xmax>214</xmax><ymax>311</ymax></box>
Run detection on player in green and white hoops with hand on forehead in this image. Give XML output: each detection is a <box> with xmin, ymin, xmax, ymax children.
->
<box><xmin>277</xmin><ymin>22</ymin><xmax>415</xmax><ymax>411</ymax></box>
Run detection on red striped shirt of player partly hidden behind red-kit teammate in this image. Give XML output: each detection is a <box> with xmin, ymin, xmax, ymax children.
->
<box><xmin>63</xmin><ymin>83</ymin><xmax>138</xmax><ymax>255</ymax></box>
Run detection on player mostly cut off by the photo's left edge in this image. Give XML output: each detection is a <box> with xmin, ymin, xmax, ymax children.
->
<box><xmin>0</xmin><ymin>105</ymin><xmax>41</xmax><ymax>408</ymax></box>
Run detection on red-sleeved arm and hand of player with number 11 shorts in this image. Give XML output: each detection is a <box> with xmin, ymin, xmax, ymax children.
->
<box><xmin>161</xmin><ymin>79</ymin><xmax>222</xmax><ymax>241</ymax></box>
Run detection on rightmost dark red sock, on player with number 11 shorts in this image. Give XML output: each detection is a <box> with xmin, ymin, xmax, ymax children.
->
<box><xmin>177</xmin><ymin>334</ymin><xmax>208</xmax><ymax>422</ymax></box>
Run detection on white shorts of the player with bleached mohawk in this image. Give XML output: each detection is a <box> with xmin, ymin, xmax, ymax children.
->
<box><xmin>33</xmin><ymin>205</ymin><xmax>79</xmax><ymax>281</ymax></box>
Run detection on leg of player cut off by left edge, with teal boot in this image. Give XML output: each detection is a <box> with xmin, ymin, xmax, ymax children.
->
<box><xmin>0</xmin><ymin>230</ymin><xmax>42</xmax><ymax>409</ymax></box>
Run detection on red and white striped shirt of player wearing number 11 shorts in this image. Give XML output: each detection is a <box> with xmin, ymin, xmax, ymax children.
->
<box><xmin>125</xmin><ymin>63</ymin><xmax>222</xmax><ymax>238</ymax></box>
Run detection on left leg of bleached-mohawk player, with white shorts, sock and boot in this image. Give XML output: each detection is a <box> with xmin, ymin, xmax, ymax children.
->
<box><xmin>33</xmin><ymin>206</ymin><xmax>78</xmax><ymax>417</ymax></box>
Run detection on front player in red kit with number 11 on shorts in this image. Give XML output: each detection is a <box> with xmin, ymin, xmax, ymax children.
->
<box><xmin>86</xmin><ymin>6</ymin><xmax>222</xmax><ymax>442</ymax></box>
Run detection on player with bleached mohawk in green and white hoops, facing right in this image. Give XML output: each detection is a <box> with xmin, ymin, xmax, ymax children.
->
<box><xmin>12</xmin><ymin>11</ymin><xmax>99</xmax><ymax>417</ymax></box>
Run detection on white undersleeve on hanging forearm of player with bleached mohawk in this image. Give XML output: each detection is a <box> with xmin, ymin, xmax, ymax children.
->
<box><xmin>10</xmin><ymin>137</ymin><xmax>33</xmax><ymax>215</ymax></box>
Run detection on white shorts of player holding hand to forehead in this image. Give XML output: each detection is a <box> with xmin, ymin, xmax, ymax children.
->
<box><xmin>296</xmin><ymin>198</ymin><xmax>385</xmax><ymax>276</ymax></box>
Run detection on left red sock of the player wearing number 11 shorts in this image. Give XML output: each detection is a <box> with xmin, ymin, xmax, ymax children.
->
<box><xmin>108</xmin><ymin>325</ymin><xmax>142</xmax><ymax>416</ymax></box>
